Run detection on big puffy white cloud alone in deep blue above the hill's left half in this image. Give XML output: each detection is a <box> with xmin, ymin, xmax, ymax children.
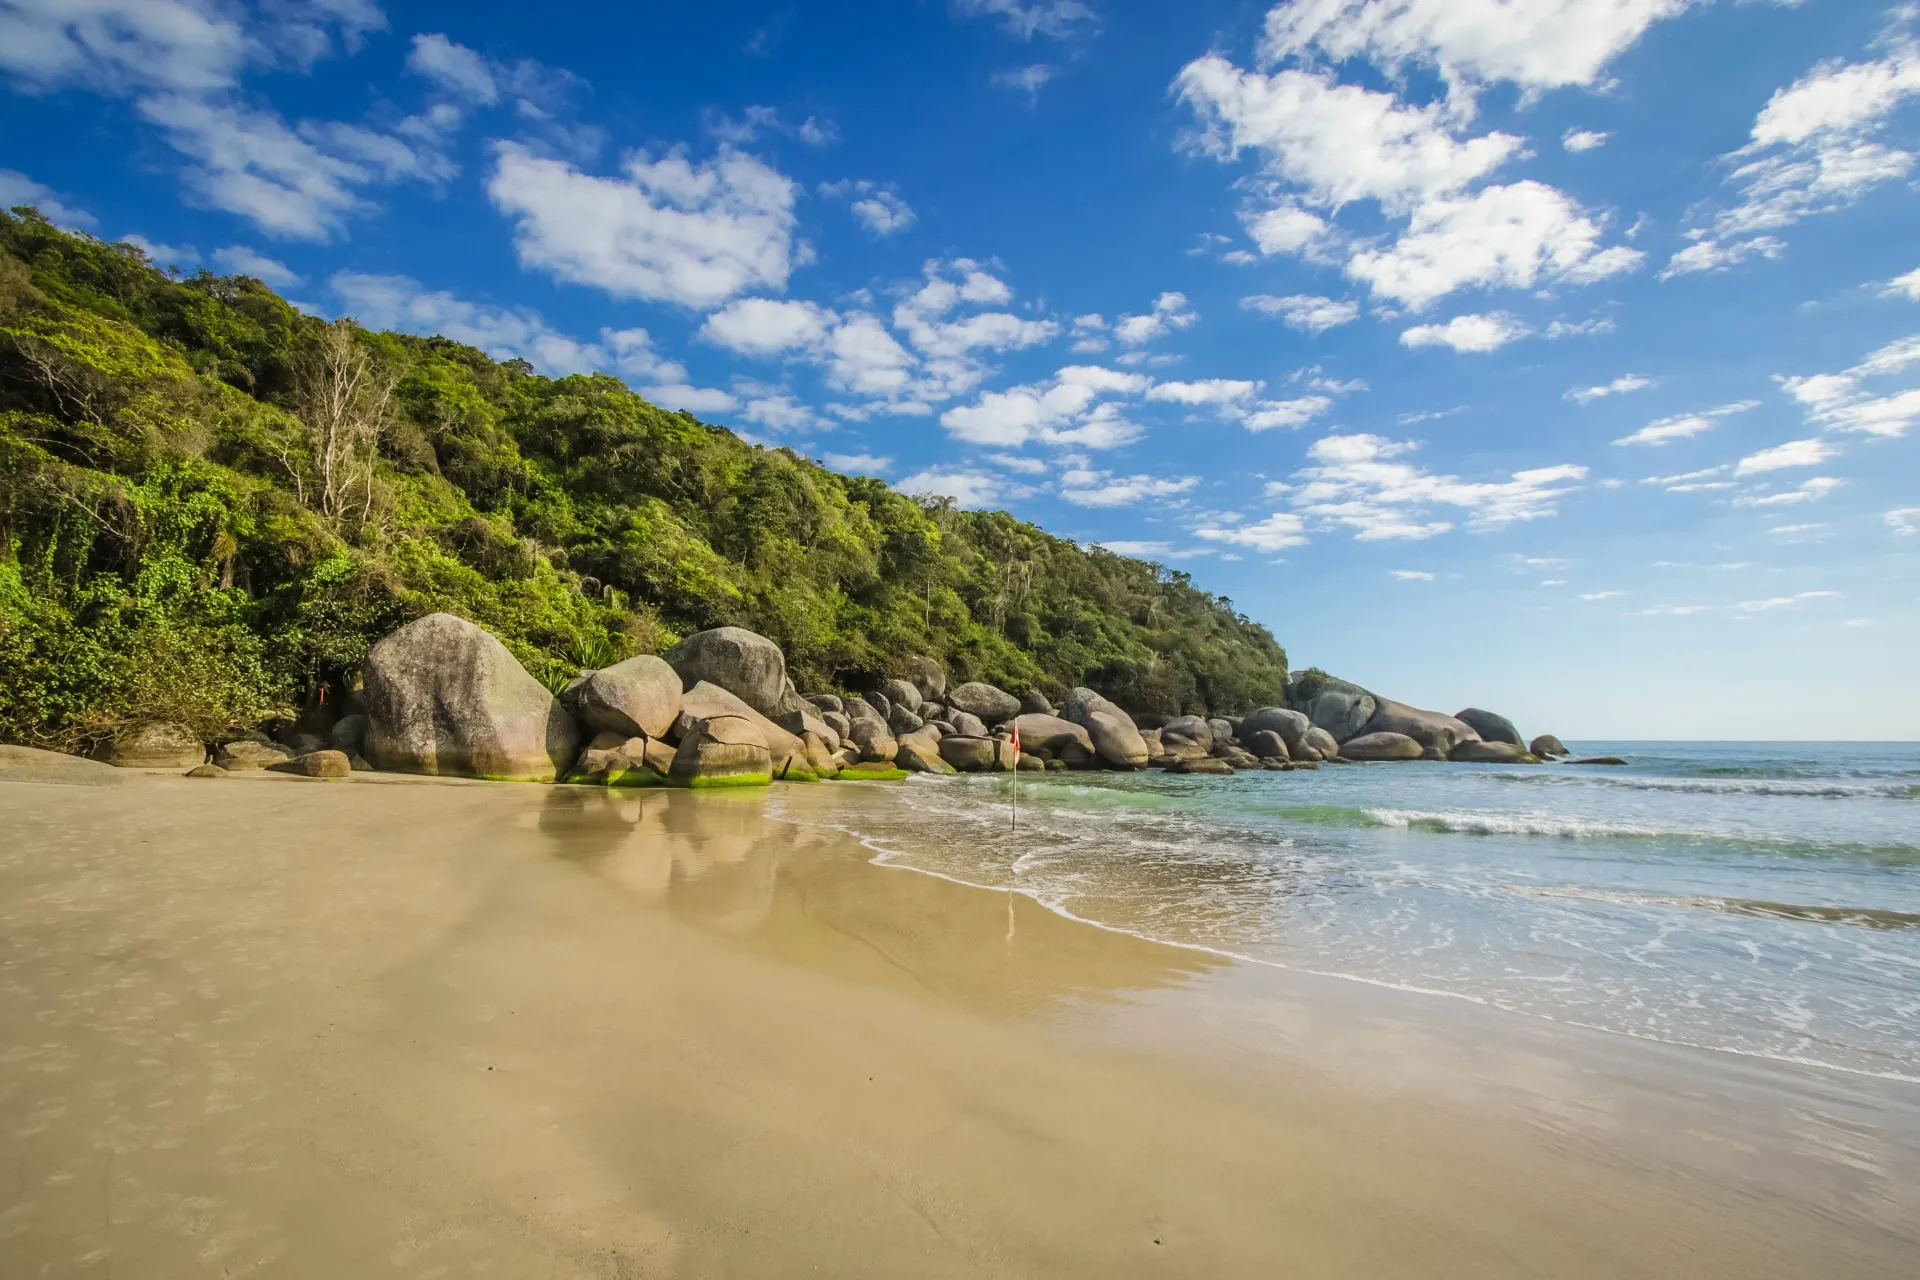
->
<box><xmin>488</xmin><ymin>142</ymin><xmax>797</xmax><ymax>307</ymax></box>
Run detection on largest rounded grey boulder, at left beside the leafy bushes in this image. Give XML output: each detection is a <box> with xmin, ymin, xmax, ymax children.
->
<box><xmin>361</xmin><ymin>614</ymin><xmax>580</xmax><ymax>783</ymax></box>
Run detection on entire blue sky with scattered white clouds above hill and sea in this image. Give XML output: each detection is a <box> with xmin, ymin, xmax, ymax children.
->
<box><xmin>0</xmin><ymin>0</ymin><xmax>1920</xmax><ymax>739</ymax></box>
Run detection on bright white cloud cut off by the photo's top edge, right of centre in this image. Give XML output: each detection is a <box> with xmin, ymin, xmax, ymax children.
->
<box><xmin>1261</xmin><ymin>0</ymin><xmax>1688</xmax><ymax>92</ymax></box>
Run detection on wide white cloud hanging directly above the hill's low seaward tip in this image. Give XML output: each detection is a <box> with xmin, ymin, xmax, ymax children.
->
<box><xmin>1288</xmin><ymin>434</ymin><xmax>1588</xmax><ymax>541</ymax></box>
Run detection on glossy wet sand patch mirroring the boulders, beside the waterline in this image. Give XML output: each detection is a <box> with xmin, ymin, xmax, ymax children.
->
<box><xmin>538</xmin><ymin>785</ymin><xmax>1227</xmax><ymax>1013</ymax></box>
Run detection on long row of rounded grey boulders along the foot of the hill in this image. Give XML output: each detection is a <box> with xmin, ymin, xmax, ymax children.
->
<box><xmin>35</xmin><ymin>612</ymin><xmax>1611</xmax><ymax>787</ymax></box>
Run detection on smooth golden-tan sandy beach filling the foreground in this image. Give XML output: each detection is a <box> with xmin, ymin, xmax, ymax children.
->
<box><xmin>0</xmin><ymin>777</ymin><xmax>1920</xmax><ymax>1280</ymax></box>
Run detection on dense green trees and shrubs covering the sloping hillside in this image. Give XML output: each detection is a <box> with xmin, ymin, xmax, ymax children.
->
<box><xmin>0</xmin><ymin>209</ymin><xmax>1286</xmax><ymax>748</ymax></box>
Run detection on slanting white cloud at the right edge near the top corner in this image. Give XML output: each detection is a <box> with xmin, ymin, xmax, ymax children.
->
<box><xmin>1665</xmin><ymin>33</ymin><xmax>1920</xmax><ymax>274</ymax></box>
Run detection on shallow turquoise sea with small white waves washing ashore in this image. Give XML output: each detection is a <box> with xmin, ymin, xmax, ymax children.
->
<box><xmin>779</xmin><ymin>743</ymin><xmax>1920</xmax><ymax>1079</ymax></box>
